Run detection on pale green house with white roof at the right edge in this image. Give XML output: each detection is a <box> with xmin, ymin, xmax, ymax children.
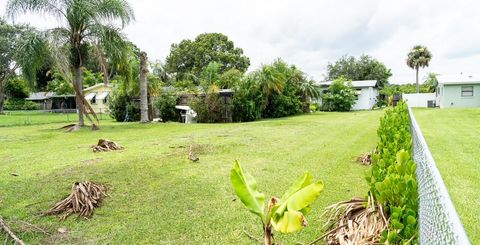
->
<box><xmin>435</xmin><ymin>75</ymin><xmax>480</xmax><ymax>108</ymax></box>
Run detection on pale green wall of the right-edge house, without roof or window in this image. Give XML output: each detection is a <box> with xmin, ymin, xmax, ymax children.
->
<box><xmin>437</xmin><ymin>84</ymin><xmax>480</xmax><ymax>108</ymax></box>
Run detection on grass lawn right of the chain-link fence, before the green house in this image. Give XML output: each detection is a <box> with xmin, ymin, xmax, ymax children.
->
<box><xmin>414</xmin><ymin>109</ymin><xmax>480</xmax><ymax>244</ymax></box>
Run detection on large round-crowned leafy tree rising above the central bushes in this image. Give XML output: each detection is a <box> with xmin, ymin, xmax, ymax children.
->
<box><xmin>165</xmin><ymin>33</ymin><xmax>250</xmax><ymax>82</ymax></box>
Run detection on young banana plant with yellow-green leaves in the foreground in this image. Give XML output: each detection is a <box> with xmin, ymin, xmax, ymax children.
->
<box><xmin>230</xmin><ymin>161</ymin><xmax>323</xmax><ymax>245</ymax></box>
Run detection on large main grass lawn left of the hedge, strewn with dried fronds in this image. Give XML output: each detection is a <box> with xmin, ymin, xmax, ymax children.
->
<box><xmin>0</xmin><ymin>111</ymin><xmax>382</xmax><ymax>244</ymax></box>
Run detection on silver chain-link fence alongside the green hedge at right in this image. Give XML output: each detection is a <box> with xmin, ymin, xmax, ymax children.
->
<box><xmin>408</xmin><ymin>108</ymin><xmax>470</xmax><ymax>245</ymax></box>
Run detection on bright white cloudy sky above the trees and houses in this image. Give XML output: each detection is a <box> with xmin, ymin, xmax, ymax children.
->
<box><xmin>0</xmin><ymin>0</ymin><xmax>480</xmax><ymax>83</ymax></box>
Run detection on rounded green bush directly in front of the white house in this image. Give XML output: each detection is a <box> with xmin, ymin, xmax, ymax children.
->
<box><xmin>322</xmin><ymin>77</ymin><xmax>356</xmax><ymax>111</ymax></box>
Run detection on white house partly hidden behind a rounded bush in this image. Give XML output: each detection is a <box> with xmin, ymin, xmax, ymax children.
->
<box><xmin>318</xmin><ymin>80</ymin><xmax>379</xmax><ymax>110</ymax></box>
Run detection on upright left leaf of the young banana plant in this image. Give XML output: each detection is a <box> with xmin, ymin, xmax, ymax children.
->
<box><xmin>230</xmin><ymin>161</ymin><xmax>265</xmax><ymax>220</ymax></box>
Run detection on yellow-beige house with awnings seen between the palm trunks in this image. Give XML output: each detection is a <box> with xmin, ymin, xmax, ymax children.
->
<box><xmin>83</xmin><ymin>83</ymin><xmax>112</xmax><ymax>113</ymax></box>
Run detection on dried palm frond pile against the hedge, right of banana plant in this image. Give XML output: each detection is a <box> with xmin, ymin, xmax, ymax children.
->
<box><xmin>324</xmin><ymin>195</ymin><xmax>388</xmax><ymax>245</ymax></box>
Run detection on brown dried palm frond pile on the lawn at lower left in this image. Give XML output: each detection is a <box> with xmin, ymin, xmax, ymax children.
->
<box><xmin>44</xmin><ymin>181</ymin><xmax>107</xmax><ymax>220</ymax></box>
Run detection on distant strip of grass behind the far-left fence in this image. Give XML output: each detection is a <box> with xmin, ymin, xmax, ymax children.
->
<box><xmin>0</xmin><ymin>111</ymin><xmax>110</xmax><ymax>127</ymax></box>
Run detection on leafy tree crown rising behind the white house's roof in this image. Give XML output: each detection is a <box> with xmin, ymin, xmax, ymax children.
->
<box><xmin>326</xmin><ymin>54</ymin><xmax>392</xmax><ymax>87</ymax></box>
